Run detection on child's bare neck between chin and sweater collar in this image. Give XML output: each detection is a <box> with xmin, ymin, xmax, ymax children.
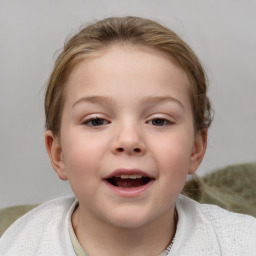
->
<box><xmin>72</xmin><ymin>206</ymin><xmax>176</xmax><ymax>256</ymax></box>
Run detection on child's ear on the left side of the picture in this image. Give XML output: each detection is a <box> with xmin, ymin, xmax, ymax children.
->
<box><xmin>44</xmin><ymin>130</ymin><xmax>68</xmax><ymax>180</ymax></box>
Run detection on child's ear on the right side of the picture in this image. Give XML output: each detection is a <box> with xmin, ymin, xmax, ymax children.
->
<box><xmin>188</xmin><ymin>130</ymin><xmax>207</xmax><ymax>174</ymax></box>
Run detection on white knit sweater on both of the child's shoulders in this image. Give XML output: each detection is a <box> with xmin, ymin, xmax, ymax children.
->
<box><xmin>0</xmin><ymin>195</ymin><xmax>256</xmax><ymax>256</ymax></box>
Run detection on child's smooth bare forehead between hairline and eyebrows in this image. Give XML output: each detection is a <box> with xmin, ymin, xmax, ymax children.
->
<box><xmin>65</xmin><ymin>44</ymin><xmax>189</xmax><ymax>108</ymax></box>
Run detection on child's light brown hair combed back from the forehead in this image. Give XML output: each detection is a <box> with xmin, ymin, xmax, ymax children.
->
<box><xmin>45</xmin><ymin>17</ymin><xmax>212</xmax><ymax>136</ymax></box>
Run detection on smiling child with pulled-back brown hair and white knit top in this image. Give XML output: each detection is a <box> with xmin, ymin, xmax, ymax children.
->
<box><xmin>0</xmin><ymin>17</ymin><xmax>256</xmax><ymax>256</ymax></box>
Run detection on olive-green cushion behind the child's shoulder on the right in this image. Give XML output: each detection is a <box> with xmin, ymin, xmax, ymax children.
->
<box><xmin>183</xmin><ymin>163</ymin><xmax>256</xmax><ymax>217</ymax></box>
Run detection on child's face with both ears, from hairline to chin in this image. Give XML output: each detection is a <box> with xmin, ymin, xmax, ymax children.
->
<box><xmin>46</xmin><ymin>45</ymin><xmax>205</xmax><ymax>227</ymax></box>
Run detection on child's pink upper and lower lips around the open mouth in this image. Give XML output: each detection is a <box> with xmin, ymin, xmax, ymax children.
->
<box><xmin>103</xmin><ymin>168</ymin><xmax>155</xmax><ymax>198</ymax></box>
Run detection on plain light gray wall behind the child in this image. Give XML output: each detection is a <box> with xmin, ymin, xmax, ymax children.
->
<box><xmin>0</xmin><ymin>0</ymin><xmax>256</xmax><ymax>207</ymax></box>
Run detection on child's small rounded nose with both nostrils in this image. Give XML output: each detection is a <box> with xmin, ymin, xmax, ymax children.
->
<box><xmin>112</xmin><ymin>121</ymin><xmax>146</xmax><ymax>155</ymax></box>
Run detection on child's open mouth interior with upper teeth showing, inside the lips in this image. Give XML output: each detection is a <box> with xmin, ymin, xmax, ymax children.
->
<box><xmin>106</xmin><ymin>174</ymin><xmax>152</xmax><ymax>188</ymax></box>
